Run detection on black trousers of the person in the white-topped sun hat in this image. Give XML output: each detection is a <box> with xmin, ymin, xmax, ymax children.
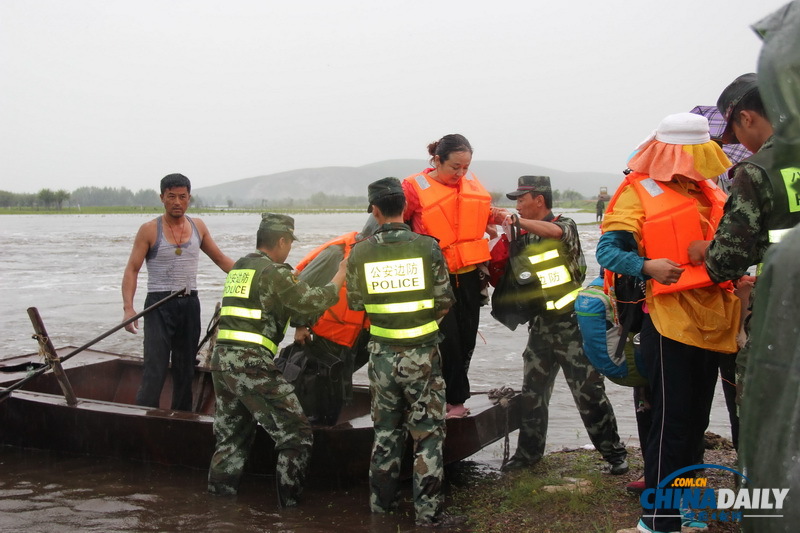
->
<box><xmin>641</xmin><ymin>315</ymin><xmax>720</xmax><ymax>531</ymax></box>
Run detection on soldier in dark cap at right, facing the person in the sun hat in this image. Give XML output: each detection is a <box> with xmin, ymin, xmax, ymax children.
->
<box><xmin>689</xmin><ymin>73</ymin><xmax>800</xmax><ymax>396</ymax></box>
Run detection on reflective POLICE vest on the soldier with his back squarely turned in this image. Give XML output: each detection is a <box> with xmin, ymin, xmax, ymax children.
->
<box><xmin>350</xmin><ymin>232</ymin><xmax>439</xmax><ymax>345</ymax></box>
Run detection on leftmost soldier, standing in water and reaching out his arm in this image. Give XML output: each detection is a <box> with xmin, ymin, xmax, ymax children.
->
<box><xmin>208</xmin><ymin>213</ymin><xmax>345</xmax><ymax>506</ymax></box>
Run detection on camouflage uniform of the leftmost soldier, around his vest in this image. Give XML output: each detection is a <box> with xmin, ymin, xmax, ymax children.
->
<box><xmin>208</xmin><ymin>251</ymin><xmax>338</xmax><ymax>505</ymax></box>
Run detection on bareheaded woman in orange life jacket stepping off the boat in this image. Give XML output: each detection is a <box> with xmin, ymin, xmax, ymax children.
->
<box><xmin>403</xmin><ymin>134</ymin><xmax>509</xmax><ymax>418</ymax></box>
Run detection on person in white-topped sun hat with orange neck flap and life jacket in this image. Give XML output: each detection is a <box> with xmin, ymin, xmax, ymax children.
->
<box><xmin>597</xmin><ymin>113</ymin><xmax>740</xmax><ymax>532</ymax></box>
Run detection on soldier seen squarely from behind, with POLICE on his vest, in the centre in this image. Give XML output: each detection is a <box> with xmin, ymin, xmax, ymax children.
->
<box><xmin>347</xmin><ymin>178</ymin><xmax>457</xmax><ymax>527</ymax></box>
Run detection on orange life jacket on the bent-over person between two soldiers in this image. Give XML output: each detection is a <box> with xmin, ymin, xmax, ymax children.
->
<box><xmin>295</xmin><ymin>231</ymin><xmax>367</xmax><ymax>348</ymax></box>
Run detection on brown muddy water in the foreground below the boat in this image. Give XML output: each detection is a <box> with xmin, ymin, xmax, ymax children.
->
<box><xmin>0</xmin><ymin>447</ymin><xmax>432</xmax><ymax>533</ymax></box>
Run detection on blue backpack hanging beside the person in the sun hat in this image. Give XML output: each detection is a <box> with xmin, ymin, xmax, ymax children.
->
<box><xmin>575</xmin><ymin>277</ymin><xmax>647</xmax><ymax>387</ymax></box>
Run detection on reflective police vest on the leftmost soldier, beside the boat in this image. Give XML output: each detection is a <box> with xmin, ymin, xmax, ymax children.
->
<box><xmin>217</xmin><ymin>254</ymin><xmax>288</xmax><ymax>355</ymax></box>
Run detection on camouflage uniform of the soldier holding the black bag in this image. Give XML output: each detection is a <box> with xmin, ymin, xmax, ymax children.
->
<box><xmin>514</xmin><ymin>214</ymin><xmax>627</xmax><ymax>465</ymax></box>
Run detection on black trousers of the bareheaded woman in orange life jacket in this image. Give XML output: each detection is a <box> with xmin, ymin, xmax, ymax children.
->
<box><xmin>439</xmin><ymin>269</ymin><xmax>481</xmax><ymax>405</ymax></box>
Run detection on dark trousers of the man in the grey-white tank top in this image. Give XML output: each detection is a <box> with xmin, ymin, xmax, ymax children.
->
<box><xmin>136</xmin><ymin>292</ymin><xmax>201</xmax><ymax>411</ymax></box>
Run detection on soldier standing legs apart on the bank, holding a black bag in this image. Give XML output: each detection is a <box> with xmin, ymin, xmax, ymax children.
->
<box><xmin>503</xmin><ymin>176</ymin><xmax>628</xmax><ymax>475</ymax></box>
